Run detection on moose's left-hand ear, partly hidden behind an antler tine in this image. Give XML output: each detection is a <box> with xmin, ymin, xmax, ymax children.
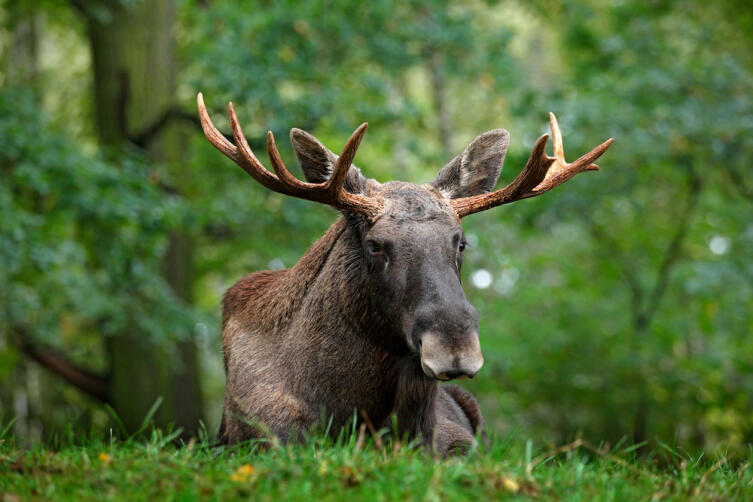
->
<box><xmin>290</xmin><ymin>128</ymin><xmax>366</xmax><ymax>193</ymax></box>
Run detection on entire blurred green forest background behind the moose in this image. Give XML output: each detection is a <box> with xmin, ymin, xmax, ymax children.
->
<box><xmin>0</xmin><ymin>0</ymin><xmax>753</xmax><ymax>453</ymax></box>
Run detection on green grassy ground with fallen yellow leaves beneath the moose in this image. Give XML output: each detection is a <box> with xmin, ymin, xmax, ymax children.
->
<box><xmin>0</xmin><ymin>431</ymin><xmax>753</xmax><ymax>502</ymax></box>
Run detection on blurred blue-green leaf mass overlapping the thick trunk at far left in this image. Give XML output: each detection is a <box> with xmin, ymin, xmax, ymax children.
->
<box><xmin>0</xmin><ymin>89</ymin><xmax>197</xmax><ymax>341</ymax></box>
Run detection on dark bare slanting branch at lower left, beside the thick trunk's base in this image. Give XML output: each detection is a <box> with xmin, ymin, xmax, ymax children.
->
<box><xmin>13</xmin><ymin>328</ymin><xmax>110</xmax><ymax>403</ymax></box>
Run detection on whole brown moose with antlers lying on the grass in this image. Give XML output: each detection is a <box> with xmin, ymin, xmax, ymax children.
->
<box><xmin>197</xmin><ymin>93</ymin><xmax>613</xmax><ymax>456</ymax></box>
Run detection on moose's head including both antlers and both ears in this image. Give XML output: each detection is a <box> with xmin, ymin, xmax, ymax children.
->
<box><xmin>198</xmin><ymin>93</ymin><xmax>613</xmax><ymax>380</ymax></box>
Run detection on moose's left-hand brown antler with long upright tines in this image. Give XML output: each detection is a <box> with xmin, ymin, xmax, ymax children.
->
<box><xmin>196</xmin><ymin>93</ymin><xmax>382</xmax><ymax>219</ymax></box>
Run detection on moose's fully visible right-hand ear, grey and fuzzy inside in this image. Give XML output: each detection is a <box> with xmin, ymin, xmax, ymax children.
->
<box><xmin>431</xmin><ymin>129</ymin><xmax>510</xmax><ymax>199</ymax></box>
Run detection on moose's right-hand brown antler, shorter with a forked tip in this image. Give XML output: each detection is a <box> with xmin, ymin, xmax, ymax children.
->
<box><xmin>450</xmin><ymin>113</ymin><xmax>614</xmax><ymax>218</ymax></box>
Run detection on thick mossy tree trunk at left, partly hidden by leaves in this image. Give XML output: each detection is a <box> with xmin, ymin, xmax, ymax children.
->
<box><xmin>88</xmin><ymin>0</ymin><xmax>203</xmax><ymax>434</ymax></box>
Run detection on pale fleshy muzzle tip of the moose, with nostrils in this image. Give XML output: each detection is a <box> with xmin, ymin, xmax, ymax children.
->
<box><xmin>420</xmin><ymin>331</ymin><xmax>484</xmax><ymax>380</ymax></box>
